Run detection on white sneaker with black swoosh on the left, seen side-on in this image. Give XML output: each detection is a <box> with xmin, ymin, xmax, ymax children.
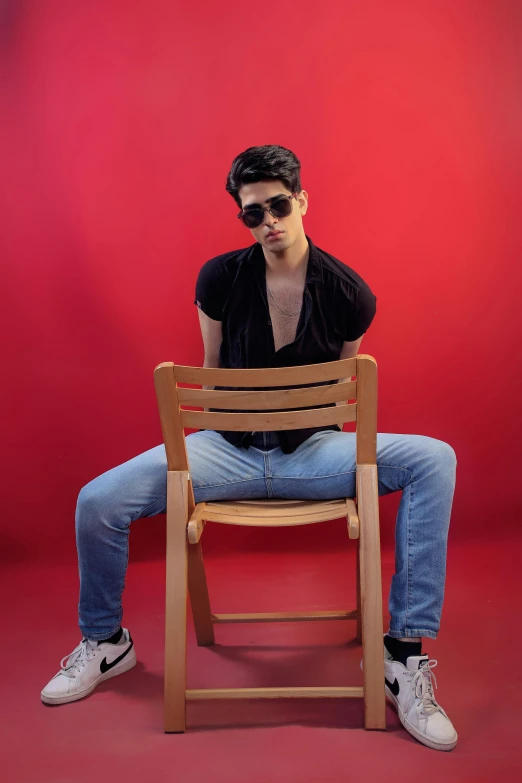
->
<box><xmin>41</xmin><ymin>628</ymin><xmax>136</xmax><ymax>704</ymax></box>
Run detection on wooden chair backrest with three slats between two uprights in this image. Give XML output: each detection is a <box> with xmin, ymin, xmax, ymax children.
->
<box><xmin>154</xmin><ymin>354</ymin><xmax>377</xmax><ymax>486</ymax></box>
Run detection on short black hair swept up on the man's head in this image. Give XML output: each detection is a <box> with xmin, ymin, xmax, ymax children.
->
<box><xmin>223</xmin><ymin>144</ymin><xmax>302</xmax><ymax>207</ymax></box>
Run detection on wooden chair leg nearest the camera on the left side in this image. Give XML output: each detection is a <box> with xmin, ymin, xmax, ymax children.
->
<box><xmin>165</xmin><ymin>471</ymin><xmax>189</xmax><ymax>733</ymax></box>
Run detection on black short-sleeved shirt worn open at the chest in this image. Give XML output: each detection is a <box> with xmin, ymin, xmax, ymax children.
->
<box><xmin>194</xmin><ymin>237</ymin><xmax>376</xmax><ymax>454</ymax></box>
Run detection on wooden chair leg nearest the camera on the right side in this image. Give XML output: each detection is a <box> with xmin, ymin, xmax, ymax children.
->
<box><xmin>357</xmin><ymin>465</ymin><xmax>386</xmax><ymax>729</ymax></box>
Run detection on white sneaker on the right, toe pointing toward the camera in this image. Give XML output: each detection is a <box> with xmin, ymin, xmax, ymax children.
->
<box><xmin>384</xmin><ymin>648</ymin><xmax>458</xmax><ymax>750</ymax></box>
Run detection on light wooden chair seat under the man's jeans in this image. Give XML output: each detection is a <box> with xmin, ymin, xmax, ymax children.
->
<box><xmin>188</xmin><ymin>498</ymin><xmax>359</xmax><ymax>544</ymax></box>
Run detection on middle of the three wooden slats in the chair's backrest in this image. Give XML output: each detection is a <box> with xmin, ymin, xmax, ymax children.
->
<box><xmin>178</xmin><ymin>381</ymin><xmax>357</xmax><ymax>411</ymax></box>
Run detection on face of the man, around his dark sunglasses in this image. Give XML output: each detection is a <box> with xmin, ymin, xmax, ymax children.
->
<box><xmin>239</xmin><ymin>179</ymin><xmax>308</xmax><ymax>253</ymax></box>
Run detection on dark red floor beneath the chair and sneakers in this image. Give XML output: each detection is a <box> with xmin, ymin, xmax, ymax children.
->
<box><xmin>5</xmin><ymin>523</ymin><xmax>522</xmax><ymax>783</ymax></box>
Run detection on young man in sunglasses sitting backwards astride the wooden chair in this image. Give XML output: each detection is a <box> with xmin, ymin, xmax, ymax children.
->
<box><xmin>41</xmin><ymin>146</ymin><xmax>457</xmax><ymax>750</ymax></box>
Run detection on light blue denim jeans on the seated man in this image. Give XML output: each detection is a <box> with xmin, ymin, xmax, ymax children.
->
<box><xmin>76</xmin><ymin>430</ymin><xmax>456</xmax><ymax>640</ymax></box>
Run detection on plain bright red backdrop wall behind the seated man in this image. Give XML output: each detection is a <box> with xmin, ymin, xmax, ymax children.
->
<box><xmin>0</xmin><ymin>0</ymin><xmax>522</xmax><ymax>560</ymax></box>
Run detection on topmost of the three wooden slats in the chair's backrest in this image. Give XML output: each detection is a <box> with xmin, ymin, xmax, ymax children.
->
<box><xmin>174</xmin><ymin>357</ymin><xmax>357</xmax><ymax>388</ymax></box>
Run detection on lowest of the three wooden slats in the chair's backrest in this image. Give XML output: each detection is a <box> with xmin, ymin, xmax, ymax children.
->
<box><xmin>181</xmin><ymin>403</ymin><xmax>357</xmax><ymax>432</ymax></box>
